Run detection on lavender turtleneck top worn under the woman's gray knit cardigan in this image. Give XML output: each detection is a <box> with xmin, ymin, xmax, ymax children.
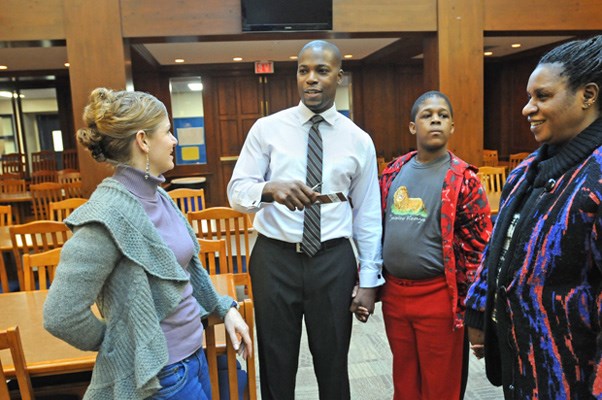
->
<box><xmin>113</xmin><ymin>165</ymin><xmax>203</xmax><ymax>364</ymax></box>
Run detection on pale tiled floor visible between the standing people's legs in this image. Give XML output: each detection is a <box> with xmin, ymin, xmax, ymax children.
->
<box><xmin>248</xmin><ymin>303</ymin><xmax>504</xmax><ymax>400</ymax></box>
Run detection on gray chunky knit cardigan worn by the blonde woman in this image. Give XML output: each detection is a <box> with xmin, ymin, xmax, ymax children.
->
<box><xmin>44</xmin><ymin>178</ymin><xmax>233</xmax><ymax>400</ymax></box>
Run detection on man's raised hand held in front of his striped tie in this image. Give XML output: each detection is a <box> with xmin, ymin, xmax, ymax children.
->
<box><xmin>261</xmin><ymin>181</ymin><xmax>320</xmax><ymax>211</ymax></box>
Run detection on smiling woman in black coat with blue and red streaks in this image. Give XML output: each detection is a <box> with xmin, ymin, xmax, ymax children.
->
<box><xmin>466</xmin><ymin>36</ymin><xmax>602</xmax><ymax>399</ymax></box>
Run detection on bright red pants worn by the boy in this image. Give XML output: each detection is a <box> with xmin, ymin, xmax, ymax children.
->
<box><xmin>382</xmin><ymin>275</ymin><xmax>464</xmax><ymax>400</ymax></box>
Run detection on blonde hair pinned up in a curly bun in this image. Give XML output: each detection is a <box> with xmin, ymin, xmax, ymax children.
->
<box><xmin>77</xmin><ymin>88</ymin><xmax>167</xmax><ymax>163</ymax></box>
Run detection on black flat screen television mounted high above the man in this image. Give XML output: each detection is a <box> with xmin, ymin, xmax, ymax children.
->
<box><xmin>241</xmin><ymin>0</ymin><xmax>332</xmax><ymax>32</ymax></box>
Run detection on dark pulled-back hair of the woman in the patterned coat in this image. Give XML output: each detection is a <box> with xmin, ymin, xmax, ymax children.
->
<box><xmin>539</xmin><ymin>35</ymin><xmax>602</xmax><ymax>99</ymax></box>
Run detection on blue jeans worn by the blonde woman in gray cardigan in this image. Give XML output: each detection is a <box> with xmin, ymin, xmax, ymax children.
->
<box><xmin>151</xmin><ymin>348</ymin><xmax>211</xmax><ymax>400</ymax></box>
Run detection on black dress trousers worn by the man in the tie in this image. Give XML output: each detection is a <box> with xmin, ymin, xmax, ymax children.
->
<box><xmin>249</xmin><ymin>235</ymin><xmax>357</xmax><ymax>400</ymax></box>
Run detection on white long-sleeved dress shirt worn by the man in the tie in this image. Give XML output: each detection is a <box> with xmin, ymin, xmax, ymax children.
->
<box><xmin>228</xmin><ymin>102</ymin><xmax>384</xmax><ymax>287</ymax></box>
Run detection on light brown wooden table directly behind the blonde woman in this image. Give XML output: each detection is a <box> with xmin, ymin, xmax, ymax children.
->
<box><xmin>0</xmin><ymin>274</ymin><xmax>236</xmax><ymax>376</ymax></box>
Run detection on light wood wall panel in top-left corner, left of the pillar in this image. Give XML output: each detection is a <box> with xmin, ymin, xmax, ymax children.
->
<box><xmin>0</xmin><ymin>0</ymin><xmax>66</xmax><ymax>41</ymax></box>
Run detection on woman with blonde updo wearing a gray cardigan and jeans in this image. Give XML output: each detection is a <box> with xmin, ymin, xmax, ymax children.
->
<box><xmin>44</xmin><ymin>88</ymin><xmax>252</xmax><ymax>399</ymax></box>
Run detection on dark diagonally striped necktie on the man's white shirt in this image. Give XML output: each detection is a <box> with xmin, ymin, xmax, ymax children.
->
<box><xmin>301</xmin><ymin>115</ymin><xmax>324</xmax><ymax>257</ymax></box>
